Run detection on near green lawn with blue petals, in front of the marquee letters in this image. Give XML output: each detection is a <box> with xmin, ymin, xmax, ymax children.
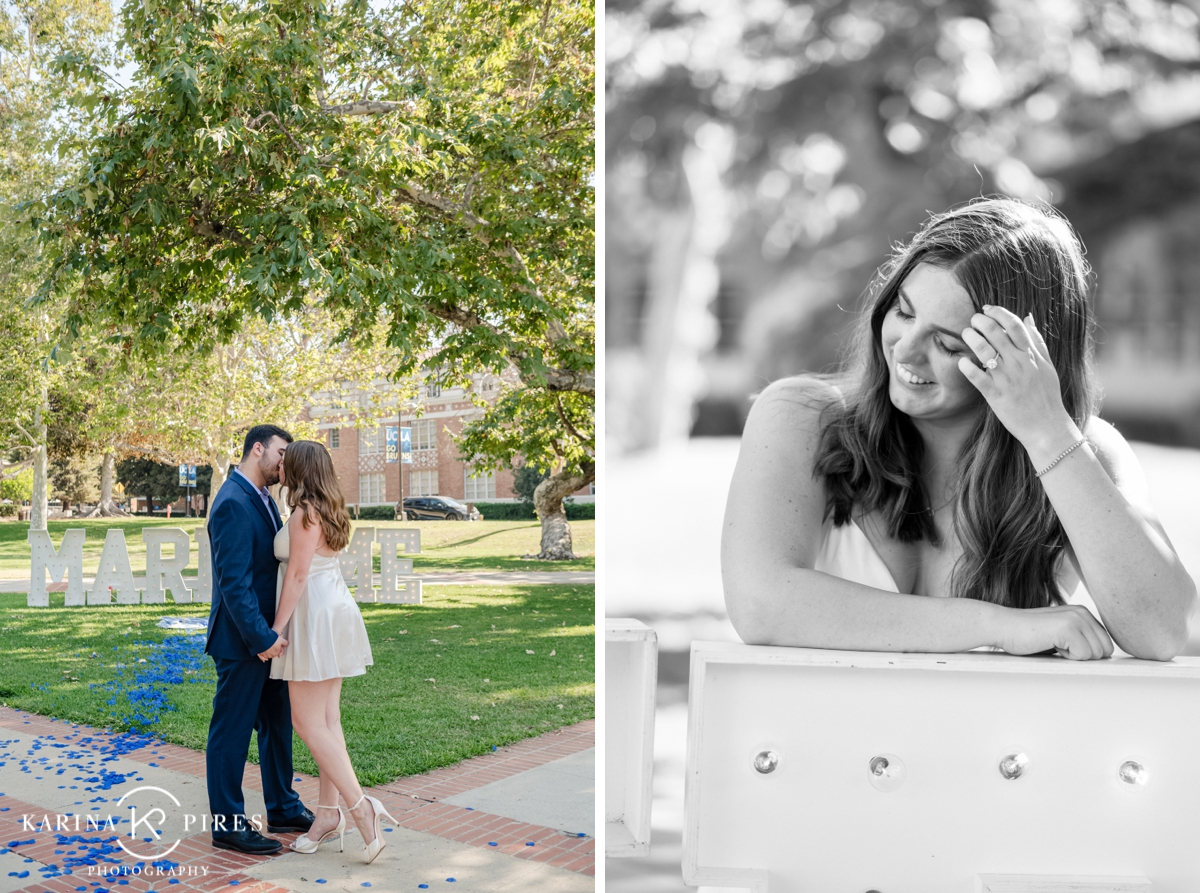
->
<box><xmin>0</xmin><ymin>590</ymin><xmax>595</xmax><ymax>785</ymax></box>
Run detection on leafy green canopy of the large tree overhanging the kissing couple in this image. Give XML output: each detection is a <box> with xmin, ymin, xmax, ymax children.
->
<box><xmin>25</xmin><ymin>0</ymin><xmax>595</xmax><ymax>552</ymax></box>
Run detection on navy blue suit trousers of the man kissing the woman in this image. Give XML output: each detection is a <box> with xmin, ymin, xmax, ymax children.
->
<box><xmin>204</xmin><ymin>655</ymin><xmax>304</xmax><ymax>837</ymax></box>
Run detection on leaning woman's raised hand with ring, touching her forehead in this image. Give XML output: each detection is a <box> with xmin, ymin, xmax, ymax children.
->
<box><xmin>959</xmin><ymin>305</ymin><xmax>1078</xmax><ymax>457</ymax></box>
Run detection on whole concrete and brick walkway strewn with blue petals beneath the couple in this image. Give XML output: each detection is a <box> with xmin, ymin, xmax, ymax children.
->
<box><xmin>0</xmin><ymin>707</ymin><xmax>595</xmax><ymax>893</ymax></box>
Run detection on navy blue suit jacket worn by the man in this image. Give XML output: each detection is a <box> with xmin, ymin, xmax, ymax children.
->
<box><xmin>204</xmin><ymin>472</ymin><xmax>280</xmax><ymax>660</ymax></box>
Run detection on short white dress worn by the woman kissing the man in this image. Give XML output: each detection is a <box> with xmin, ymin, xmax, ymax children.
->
<box><xmin>271</xmin><ymin>520</ymin><xmax>374</xmax><ymax>682</ymax></box>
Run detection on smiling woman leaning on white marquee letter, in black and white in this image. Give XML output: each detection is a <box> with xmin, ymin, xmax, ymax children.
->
<box><xmin>721</xmin><ymin>199</ymin><xmax>1195</xmax><ymax>660</ymax></box>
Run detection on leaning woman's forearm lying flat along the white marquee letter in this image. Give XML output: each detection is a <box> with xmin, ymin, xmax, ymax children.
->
<box><xmin>724</xmin><ymin>565</ymin><xmax>1008</xmax><ymax>653</ymax></box>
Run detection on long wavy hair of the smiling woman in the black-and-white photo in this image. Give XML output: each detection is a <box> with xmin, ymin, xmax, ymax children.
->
<box><xmin>816</xmin><ymin>198</ymin><xmax>1094</xmax><ymax>607</ymax></box>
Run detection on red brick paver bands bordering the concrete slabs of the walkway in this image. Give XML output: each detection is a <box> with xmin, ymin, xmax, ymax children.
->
<box><xmin>0</xmin><ymin>707</ymin><xmax>595</xmax><ymax>893</ymax></box>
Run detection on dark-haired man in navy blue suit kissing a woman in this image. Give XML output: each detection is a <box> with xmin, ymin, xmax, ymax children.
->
<box><xmin>205</xmin><ymin>425</ymin><xmax>312</xmax><ymax>855</ymax></box>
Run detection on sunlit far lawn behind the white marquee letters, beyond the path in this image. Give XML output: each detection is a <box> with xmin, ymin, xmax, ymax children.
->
<box><xmin>0</xmin><ymin>517</ymin><xmax>595</xmax><ymax>580</ymax></box>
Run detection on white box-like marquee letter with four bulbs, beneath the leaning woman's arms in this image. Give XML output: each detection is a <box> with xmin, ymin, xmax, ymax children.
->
<box><xmin>683</xmin><ymin>642</ymin><xmax>1200</xmax><ymax>893</ymax></box>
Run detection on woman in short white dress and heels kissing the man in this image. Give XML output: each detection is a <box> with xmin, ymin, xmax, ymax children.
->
<box><xmin>271</xmin><ymin>440</ymin><xmax>396</xmax><ymax>862</ymax></box>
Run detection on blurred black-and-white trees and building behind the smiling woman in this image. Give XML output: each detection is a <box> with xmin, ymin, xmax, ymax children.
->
<box><xmin>605</xmin><ymin>0</ymin><xmax>1200</xmax><ymax>453</ymax></box>
